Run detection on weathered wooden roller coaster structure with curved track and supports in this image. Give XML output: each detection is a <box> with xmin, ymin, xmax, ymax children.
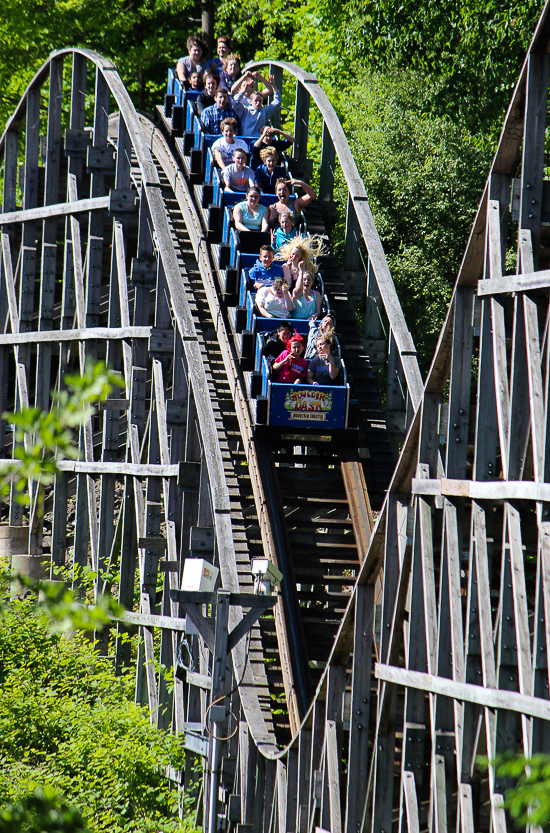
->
<box><xmin>0</xmin><ymin>1</ymin><xmax>550</xmax><ymax>833</ymax></box>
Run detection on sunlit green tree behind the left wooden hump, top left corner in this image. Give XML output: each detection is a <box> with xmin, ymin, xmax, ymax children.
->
<box><xmin>0</xmin><ymin>0</ymin><xmax>197</xmax><ymax>124</ymax></box>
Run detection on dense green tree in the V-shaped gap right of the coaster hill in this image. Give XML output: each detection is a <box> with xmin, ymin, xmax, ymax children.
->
<box><xmin>338</xmin><ymin>73</ymin><xmax>490</xmax><ymax>371</ymax></box>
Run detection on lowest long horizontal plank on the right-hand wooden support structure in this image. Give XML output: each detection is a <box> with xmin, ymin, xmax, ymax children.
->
<box><xmin>374</xmin><ymin>662</ymin><xmax>550</xmax><ymax>720</ymax></box>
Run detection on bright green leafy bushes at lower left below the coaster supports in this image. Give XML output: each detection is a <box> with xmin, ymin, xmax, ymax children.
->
<box><xmin>0</xmin><ymin>573</ymin><xmax>194</xmax><ymax>833</ymax></box>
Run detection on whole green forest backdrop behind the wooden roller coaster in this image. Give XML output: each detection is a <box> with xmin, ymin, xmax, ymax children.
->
<box><xmin>0</xmin><ymin>0</ymin><xmax>543</xmax><ymax>364</ymax></box>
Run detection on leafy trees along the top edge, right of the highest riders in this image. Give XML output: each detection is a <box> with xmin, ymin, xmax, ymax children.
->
<box><xmin>217</xmin><ymin>0</ymin><xmax>544</xmax><ymax>132</ymax></box>
